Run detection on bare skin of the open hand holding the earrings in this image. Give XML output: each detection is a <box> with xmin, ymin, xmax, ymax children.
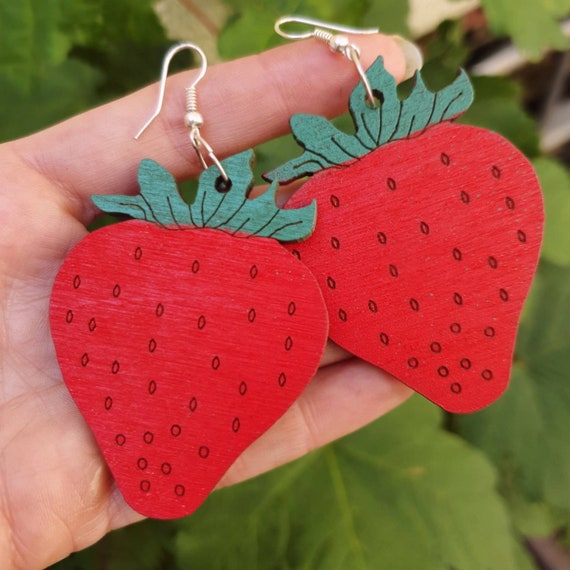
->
<box><xmin>0</xmin><ymin>35</ymin><xmax>409</xmax><ymax>570</ymax></box>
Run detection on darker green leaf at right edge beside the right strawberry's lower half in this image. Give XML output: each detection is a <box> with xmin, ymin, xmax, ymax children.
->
<box><xmin>457</xmin><ymin>263</ymin><xmax>570</xmax><ymax>510</ymax></box>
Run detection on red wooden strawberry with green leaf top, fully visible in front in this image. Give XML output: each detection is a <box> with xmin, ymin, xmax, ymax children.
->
<box><xmin>50</xmin><ymin>152</ymin><xmax>327</xmax><ymax>519</ymax></box>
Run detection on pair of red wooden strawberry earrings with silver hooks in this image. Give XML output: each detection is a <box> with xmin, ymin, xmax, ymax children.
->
<box><xmin>50</xmin><ymin>17</ymin><xmax>543</xmax><ymax>518</ymax></box>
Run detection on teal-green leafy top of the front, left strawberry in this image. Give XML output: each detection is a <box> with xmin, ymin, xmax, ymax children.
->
<box><xmin>91</xmin><ymin>150</ymin><xmax>316</xmax><ymax>242</ymax></box>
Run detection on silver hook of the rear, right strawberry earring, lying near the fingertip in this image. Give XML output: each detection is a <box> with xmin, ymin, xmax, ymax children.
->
<box><xmin>274</xmin><ymin>16</ymin><xmax>379</xmax><ymax>107</ymax></box>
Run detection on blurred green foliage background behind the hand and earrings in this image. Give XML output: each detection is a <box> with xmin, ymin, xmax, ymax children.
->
<box><xmin>0</xmin><ymin>0</ymin><xmax>570</xmax><ymax>570</ymax></box>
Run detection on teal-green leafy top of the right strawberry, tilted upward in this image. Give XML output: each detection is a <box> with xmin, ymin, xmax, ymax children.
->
<box><xmin>264</xmin><ymin>57</ymin><xmax>473</xmax><ymax>183</ymax></box>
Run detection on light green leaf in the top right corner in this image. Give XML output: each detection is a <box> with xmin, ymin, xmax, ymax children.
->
<box><xmin>481</xmin><ymin>0</ymin><xmax>570</xmax><ymax>59</ymax></box>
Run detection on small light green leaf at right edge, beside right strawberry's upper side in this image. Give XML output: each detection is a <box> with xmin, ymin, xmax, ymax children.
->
<box><xmin>534</xmin><ymin>158</ymin><xmax>570</xmax><ymax>265</ymax></box>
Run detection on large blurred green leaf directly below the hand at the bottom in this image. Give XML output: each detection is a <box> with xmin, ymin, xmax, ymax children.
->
<box><xmin>175</xmin><ymin>398</ymin><xmax>520</xmax><ymax>570</ymax></box>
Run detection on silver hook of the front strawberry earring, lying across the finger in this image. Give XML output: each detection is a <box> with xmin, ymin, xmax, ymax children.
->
<box><xmin>135</xmin><ymin>42</ymin><xmax>229</xmax><ymax>182</ymax></box>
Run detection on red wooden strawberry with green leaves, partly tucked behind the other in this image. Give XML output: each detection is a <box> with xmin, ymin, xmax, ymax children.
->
<box><xmin>267</xmin><ymin>60</ymin><xmax>543</xmax><ymax>413</ymax></box>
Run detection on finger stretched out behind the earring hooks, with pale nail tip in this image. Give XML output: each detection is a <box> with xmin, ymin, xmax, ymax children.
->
<box><xmin>13</xmin><ymin>35</ymin><xmax>406</xmax><ymax>223</ymax></box>
